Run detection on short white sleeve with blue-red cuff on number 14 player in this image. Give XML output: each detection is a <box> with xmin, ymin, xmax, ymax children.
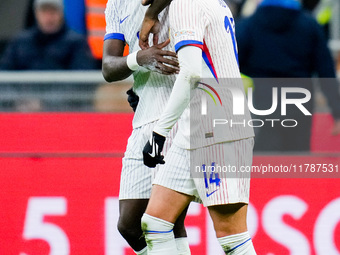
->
<box><xmin>169</xmin><ymin>0</ymin><xmax>206</xmax><ymax>52</ymax></box>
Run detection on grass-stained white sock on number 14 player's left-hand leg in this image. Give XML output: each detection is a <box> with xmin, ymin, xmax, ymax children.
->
<box><xmin>142</xmin><ymin>213</ymin><xmax>178</xmax><ymax>255</ymax></box>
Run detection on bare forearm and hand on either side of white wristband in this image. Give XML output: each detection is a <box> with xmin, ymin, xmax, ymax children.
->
<box><xmin>102</xmin><ymin>39</ymin><xmax>179</xmax><ymax>82</ymax></box>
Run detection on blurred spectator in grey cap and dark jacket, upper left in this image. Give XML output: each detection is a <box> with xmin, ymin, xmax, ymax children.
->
<box><xmin>0</xmin><ymin>0</ymin><xmax>96</xmax><ymax>70</ymax></box>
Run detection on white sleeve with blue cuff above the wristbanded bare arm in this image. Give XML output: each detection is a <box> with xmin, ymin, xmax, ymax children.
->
<box><xmin>104</xmin><ymin>0</ymin><xmax>125</xmax><ymax>42</ymax></box>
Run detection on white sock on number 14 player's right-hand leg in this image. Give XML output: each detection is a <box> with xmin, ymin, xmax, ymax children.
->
<box><xmin>217</xmin><ymin>231</ymin><xmax>256</xmax><ymax>255</ymax></box>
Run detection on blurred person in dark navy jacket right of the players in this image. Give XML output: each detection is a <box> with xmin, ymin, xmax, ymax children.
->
<box><xmin>236</xmin><ymin>0</ymin><xmax>340</xmax><ymax>151</ymax></box>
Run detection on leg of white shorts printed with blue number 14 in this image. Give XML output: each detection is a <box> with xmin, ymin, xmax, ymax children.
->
<box><xmin>191</xmin><ymin>138</ymin><xmax>254</xmax><ymax>207</ymax></box>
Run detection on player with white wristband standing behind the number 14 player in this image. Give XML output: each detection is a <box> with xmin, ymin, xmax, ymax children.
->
<box><xmin>102</xmin><ymin>0</ymin><xmax>190</xmax><ymax>255</ymax></box>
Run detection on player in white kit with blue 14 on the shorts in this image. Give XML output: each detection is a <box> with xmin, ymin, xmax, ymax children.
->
<box><xmin>141</xmin><ymin>0</ymin><xmax>256</xmax><ymax>255</ymax></box>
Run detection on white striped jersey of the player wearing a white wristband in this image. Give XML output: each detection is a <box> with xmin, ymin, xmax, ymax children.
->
<box><xmin>104</xmin><ymin>0</ymin><xmax>176</xmax><ymax>128</ymax></box>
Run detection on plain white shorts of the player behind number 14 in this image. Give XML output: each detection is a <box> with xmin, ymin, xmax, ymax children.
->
<box><xmin>119</xmin><ymin>122</ymin><xmax>177</xmax><ymax>200</ymax></box>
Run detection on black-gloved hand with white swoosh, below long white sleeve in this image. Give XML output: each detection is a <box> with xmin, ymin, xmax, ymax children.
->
<box><xmin>143</xmin><ymin>132</ymin><xmax>165</xmax><ymax>168</ymax></box>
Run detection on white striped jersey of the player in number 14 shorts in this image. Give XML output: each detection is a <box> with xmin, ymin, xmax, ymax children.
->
<box><xmin>169</xmin><ymin>0</ymin><xmax>254</xmax><ymax>149</ymax></box>
